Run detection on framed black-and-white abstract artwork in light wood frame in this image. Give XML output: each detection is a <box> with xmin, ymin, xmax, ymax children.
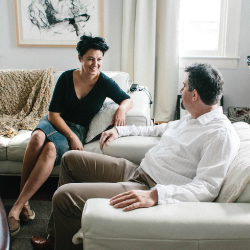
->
<box><xmin>15</xmin><ymin>0</ymin><xmax>103</xmax><ymax>47</ymax></box>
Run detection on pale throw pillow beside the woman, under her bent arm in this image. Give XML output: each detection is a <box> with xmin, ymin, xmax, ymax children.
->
<box><xmin>85</xmin><ymin>101</ymin><xmax>119</xmax><ymax>143</ymax></box>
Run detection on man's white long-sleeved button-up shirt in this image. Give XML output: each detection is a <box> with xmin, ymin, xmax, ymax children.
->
<box><xmin>116</xmin><ymin>107</ymin><xmax>240</xmax><ymax>204</ymax></box>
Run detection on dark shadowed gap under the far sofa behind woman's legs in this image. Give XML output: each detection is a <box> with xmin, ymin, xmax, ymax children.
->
<box><xmin>0</xmin><ymin>176</ymin><xmax>58</xmax><ymax>201</ymax></box>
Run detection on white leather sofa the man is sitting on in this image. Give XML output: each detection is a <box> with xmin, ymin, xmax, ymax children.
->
<box><xmin>73</xmin><ymin>122</ymin><xmax>250</xmax><ymax>250</ymax></box>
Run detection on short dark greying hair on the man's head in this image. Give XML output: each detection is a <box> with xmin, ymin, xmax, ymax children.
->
<box><xmin>185</xmin><ymin>63</ymin><xmax>224</xmax><ymax>105</ymax></box>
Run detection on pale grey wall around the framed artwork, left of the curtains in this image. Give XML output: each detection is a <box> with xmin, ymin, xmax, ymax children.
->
<box><xmin>0</xmin><ymin>0</ymin><xmax>122</xmax><ymax>70</ymax></box>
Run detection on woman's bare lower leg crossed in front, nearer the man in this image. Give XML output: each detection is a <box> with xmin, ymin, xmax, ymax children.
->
<box><xmin>9</xmin><ymin>141</ymin><xmax>56</xmax><ymax>220</ymax></box>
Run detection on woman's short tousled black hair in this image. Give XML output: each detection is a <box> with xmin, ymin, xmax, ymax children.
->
<box><xmin>76</xmin><ymin>35</ymin><xmax>109</xmax><ymax>57</ymax></box>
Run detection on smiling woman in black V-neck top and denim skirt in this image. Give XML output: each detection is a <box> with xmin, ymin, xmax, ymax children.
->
<box><xmin>8</xmin><ymin>35</ymin><xmax>132</xmax><ymax>236</ymax></box>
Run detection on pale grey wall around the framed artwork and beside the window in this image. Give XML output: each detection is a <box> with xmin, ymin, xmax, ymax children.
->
<box><xmin>0</xmin><ymin>0</ymin><xmax>250</xmax><ymax>112</ymax></box>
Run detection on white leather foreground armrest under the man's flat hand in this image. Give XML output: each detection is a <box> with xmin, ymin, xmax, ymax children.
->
<box><xmin>73</xmin><ymin>199</ymin><xmax>250</xmax><ymax>250</ymax></box>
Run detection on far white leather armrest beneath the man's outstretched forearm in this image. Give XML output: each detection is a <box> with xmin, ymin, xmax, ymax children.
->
<box><xmin>103</xmin><ymin>136</ymin><xmax>161</xmax><ymax>165</ymax></box>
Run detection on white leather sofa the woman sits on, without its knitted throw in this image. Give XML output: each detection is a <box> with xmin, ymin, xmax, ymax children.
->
<box><xmin>0</xmin><ymin>71</ymin><xmax>151</xmax><ymax>176</ymax></box>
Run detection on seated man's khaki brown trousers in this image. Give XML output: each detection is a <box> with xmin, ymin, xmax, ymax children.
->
<box><xmin>48</xmin><ymin>150</ymin><xmax>155</xmax><ymax>250</ymax></box>
